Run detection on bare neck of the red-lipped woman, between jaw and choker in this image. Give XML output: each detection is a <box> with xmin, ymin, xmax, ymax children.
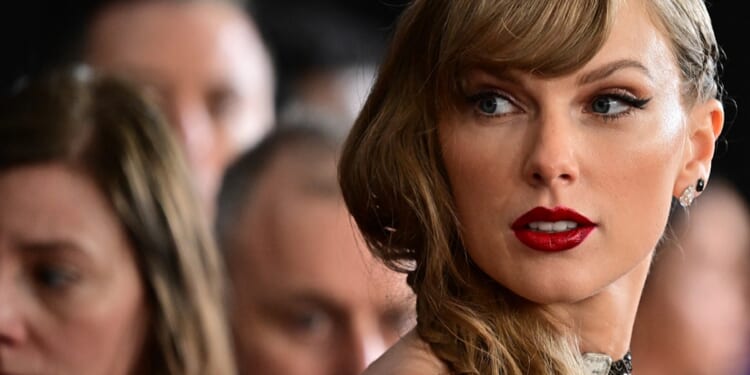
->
<box><xmin>548</xmin><ymin>251</ymin><xmax>651</xmax><ymax>360</ymax></box>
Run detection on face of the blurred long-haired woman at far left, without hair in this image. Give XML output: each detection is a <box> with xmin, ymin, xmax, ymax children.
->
<box><xmin>0</xmin><ymin>164</ymin><xmax>146</xmax><ymax>375</ymax></box>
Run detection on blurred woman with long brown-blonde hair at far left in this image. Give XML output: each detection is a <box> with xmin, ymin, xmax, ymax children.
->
<box><xmin>0</xmin><ymin>69</ymin><xmax>234</xmax><ymax>375</ymax></box>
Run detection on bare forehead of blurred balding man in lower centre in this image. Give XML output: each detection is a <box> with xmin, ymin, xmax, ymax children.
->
<box><xmin>248</xmin><ymin>194</ymin><xmax>405</xmax><ymax>307</ymax></box>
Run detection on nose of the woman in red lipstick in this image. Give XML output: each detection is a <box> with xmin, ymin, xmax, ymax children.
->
<box><xmin>523</xmin><ymin>111</ymin><xmax>585</xmax><ymax>187</ymax></box>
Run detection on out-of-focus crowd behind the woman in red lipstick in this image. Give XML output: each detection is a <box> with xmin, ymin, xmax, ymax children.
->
<box><xmin>0</xmin><ymin>0</ymin><xmax>750</xmax><ymax>375</ymax></box>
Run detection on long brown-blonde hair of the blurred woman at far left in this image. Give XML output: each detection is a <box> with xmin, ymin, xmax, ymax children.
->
<box><xmin>0</xmin><ymin>69</ymin><xmax>235</xmax><ymax>375</ymax></box>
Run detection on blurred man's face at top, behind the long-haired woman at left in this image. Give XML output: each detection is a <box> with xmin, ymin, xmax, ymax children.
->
<box><xmin>87</xmin><ymin>1</ymin><xmax>274</xmax><ymax>210</ymax></box>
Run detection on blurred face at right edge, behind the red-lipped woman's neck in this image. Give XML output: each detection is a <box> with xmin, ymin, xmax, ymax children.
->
<box><xmin>633</xmin><ymin>184</ymin><xmax>750</xmax><ymax>375</ymax></box>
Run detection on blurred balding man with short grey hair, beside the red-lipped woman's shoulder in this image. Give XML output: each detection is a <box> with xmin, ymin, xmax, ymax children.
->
<box><xmin>218</xmin><ymin>128</ymin><xmax>414</xmax><ymax>375</ymax></box>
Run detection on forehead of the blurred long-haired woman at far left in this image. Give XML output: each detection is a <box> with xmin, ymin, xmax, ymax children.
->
<box><xmin>0</xmin><ymin>164</ymin><xmax>127</xmax><ymax>255</ymax></box>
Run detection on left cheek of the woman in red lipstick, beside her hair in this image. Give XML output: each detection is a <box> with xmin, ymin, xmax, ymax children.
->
<box><xmin>439</xmin><ymin>123</ymin><xmax>525</xmax><ymax>278</ymax></box>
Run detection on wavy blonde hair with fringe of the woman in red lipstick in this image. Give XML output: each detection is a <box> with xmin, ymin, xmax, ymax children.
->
<box><xmin>339</xmin><ymin>0</ymin><xmax>719</xmax><ymax>375</ymax></box>
